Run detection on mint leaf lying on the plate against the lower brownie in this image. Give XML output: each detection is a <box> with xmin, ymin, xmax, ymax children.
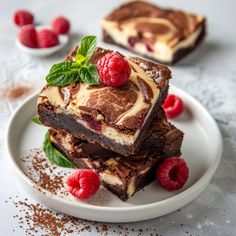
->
<box><xmin>43</xmin><ymin>132</ymin><xmax>74</xmax><ymax>167</ymax></box>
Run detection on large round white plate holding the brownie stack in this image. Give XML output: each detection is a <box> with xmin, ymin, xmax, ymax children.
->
<box><xmin>6</xmin><ymin>87</ymin><xmax>222</xmax><ymax>222</ymax></box>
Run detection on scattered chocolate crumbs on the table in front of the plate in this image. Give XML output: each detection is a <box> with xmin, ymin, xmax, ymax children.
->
<box><xmin>7</xmin><ymin>195</ymin><xmax>162</xmax><ymax>236</ymax></box>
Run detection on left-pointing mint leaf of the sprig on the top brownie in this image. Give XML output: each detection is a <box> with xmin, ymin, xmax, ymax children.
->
<box><xmin>46</xmin><ymin>61</ymin><xmax>79</xmax><ymax>86</ymax></box>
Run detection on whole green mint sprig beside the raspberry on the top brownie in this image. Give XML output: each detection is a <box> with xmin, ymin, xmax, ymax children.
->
<box><xmin>46</xmin><ymin>36</ymin><xmax>99</xmax><ymax>86</ymax></box>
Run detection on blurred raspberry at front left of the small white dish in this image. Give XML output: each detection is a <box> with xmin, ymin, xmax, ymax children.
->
<box><xmin>18</xmin><ymin>25</ymin><xmax>38</xmax><ymax>48</ymax></box>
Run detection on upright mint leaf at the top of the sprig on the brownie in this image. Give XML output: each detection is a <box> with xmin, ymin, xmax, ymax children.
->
<box><xmin>76</xmin><ymin>36</ymin><xmax>97</xmax><ymax>61</ymax></box>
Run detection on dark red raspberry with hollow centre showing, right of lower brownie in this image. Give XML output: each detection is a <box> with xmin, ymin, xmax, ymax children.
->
<box><xmin>156</xmin><ymin>157</ymin><xmax>189</xmax><ymax>190</ymax></box>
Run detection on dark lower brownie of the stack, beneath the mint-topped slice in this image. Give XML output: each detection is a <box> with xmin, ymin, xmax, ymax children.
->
<box><xmin>50</xmin><ymin>115</ymin><xmax>183</xmax><ymax>201</ymax></box>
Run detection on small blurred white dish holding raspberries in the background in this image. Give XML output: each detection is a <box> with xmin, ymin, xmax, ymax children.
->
<box><xmin>16</xmin><ymin>25</ymin><xmax>69</xmax><ymax>57</ymax></box>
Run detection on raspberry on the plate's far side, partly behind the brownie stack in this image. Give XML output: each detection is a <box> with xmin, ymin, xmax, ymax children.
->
<box><xmin>162</xmin><ymin>94</ymin><xmax>184</xmax><ymax>118</ymax></box>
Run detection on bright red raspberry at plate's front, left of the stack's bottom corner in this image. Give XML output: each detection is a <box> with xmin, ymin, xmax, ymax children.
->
<box><xmin>67</xmin><ymin>170</ymin><xmax>100</xmax><ymax>199</ymax></box>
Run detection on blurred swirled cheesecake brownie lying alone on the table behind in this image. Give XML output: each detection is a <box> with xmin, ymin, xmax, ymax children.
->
<box><xmin>102</xmin><ymin>1</ymin><xmax>206</xmax><ymax>64</ymax></box>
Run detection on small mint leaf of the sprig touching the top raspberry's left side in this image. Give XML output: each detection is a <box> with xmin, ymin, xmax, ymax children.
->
<box><xmin>79</xmin><ymin>64</ymin><xmax>99</xmax><ymax>85</ymax></box>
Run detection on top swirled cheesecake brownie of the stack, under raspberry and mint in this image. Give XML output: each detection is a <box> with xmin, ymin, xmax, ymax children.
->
<box><xmin>37</xmin><ymin>48</ymin><xmax>171</xmax><ymax>156</ymax></box>
